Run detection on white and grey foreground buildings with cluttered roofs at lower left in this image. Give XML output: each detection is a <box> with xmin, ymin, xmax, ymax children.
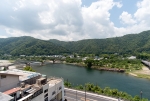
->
<box><xmin>0</xmin><ymin>69</ymin><xmax>64</xmax><ymax>101</ymax></box>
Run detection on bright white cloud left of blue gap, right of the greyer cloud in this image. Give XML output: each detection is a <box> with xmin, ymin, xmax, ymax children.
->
<box><xmin>82</xmin><ymin>0</ymin><xmax>119</xmax><ymax>38</ymax></box>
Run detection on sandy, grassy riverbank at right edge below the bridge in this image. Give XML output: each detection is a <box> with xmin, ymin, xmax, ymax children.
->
<box><xmin>127</xmin><ymin>66</ymin><xmax>150</xmax><ymax>79</ymax></box>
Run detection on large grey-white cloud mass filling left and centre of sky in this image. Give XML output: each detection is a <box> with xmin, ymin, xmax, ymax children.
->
<box><xmin>0</xmin><ymin>0</ymin><xmax>121</xmax><ymax>40</ymax></box>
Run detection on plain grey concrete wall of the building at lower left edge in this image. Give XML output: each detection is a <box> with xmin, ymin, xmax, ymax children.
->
<box><xmin>0</xmin><ymin>75</ymin><xmax>19</xmax><ymax>92</ymax></box>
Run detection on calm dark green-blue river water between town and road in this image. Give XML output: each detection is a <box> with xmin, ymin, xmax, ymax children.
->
<box><xmin>33</xmin><ymin>64</ymin><xmax>150</xmax><ymax>99</ymax></box>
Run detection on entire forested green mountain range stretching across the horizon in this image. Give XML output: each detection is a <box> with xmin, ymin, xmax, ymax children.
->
<box><xmin>0</xmin><ymin>31</ymin><xmax>150</xmax><ymax>55</ymax></box>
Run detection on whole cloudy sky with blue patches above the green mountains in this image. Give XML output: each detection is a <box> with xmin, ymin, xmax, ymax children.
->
<box><xmin>0</xmin><ymin>0</ymin><xmax>150</xmax><ymax>41</ymax></box>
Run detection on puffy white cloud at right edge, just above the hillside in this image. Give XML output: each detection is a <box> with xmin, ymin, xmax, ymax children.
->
<box><xmin>115</xmin><ymin>0</ymin><xmax>150</xmax><ymax>35</ymax></box>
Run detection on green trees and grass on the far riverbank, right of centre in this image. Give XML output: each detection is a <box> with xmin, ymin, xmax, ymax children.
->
<box><xmin>66</xmin><ymin>54</ymin><xmax>143</xmax><ymax>71</ymax></box>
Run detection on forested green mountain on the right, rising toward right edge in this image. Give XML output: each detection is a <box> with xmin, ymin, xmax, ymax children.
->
<box><xmin>50</xmin><ymin>31</ymin><xmax>150</xmax><ymax>54</ymax></box>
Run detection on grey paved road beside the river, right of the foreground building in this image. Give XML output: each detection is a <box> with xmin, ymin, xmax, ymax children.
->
<box><xmin>65</xmin><ymin>88</ymin><xmax>118</xmax><ymax>101</ymax></box>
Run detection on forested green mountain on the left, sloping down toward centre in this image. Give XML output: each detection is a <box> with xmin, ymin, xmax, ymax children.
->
<box><xmin>0</xmin><ymin>36</ymin><xmax>69</xmax><ymax>56</ymax></box>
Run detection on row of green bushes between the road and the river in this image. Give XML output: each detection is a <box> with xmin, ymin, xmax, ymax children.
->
<box><xmin>64</xmin><ymin>81</ymin><xmax>148</xmax><ymax>101</ymax></box>
